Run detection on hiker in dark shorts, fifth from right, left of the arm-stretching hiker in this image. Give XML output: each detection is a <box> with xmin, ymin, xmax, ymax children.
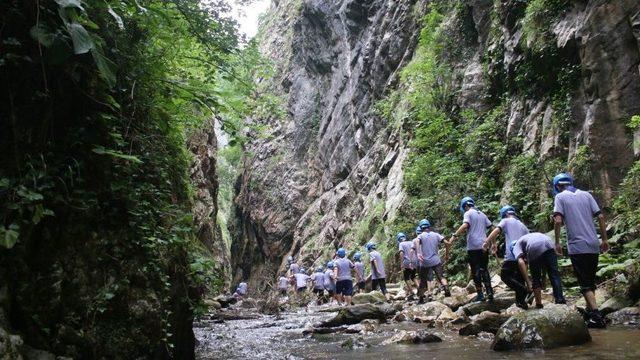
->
<box><xmin>413</xmin><ymin>219</ymin><xmax>451</xmax><ymax>304</ymax></box>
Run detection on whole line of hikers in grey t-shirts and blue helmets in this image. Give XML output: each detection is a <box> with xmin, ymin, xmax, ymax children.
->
<box><xmin>266</xmin><ymin>173</ymin><xmax>609</xmax><ymax>328</ymax></box>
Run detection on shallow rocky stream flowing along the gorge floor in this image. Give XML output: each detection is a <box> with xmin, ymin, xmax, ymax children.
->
<box><xmin>194</xmin><ymin>308</ymin><xmax>640</xmax><ymax>360</ymax></box>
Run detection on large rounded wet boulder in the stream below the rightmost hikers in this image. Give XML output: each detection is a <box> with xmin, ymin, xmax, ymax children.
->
<box><xmin>491</xmin><ymin>304</ymin><xmax>591</xmax><ymax>351</ymax></box>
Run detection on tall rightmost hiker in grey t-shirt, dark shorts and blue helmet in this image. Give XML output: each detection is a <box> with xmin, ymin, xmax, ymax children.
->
<box><xmin>553</xmin><ymin>173</ymin><xmax>609</xmax><ymax>328</ymax></box>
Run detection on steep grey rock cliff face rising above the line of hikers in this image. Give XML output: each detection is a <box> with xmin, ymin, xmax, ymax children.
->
<box><xmin>232</xmin><ymin>0</ymin><xmax>640</xmax><ymax>281</ymax></box>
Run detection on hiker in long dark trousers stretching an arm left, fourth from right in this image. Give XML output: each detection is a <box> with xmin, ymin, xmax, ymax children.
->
<box><xmin>447</xmin><ymin>197</ymin><xmax>493</xmax><ymax>301</ymax></box>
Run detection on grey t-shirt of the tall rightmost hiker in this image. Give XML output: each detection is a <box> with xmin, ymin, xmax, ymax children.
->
<box><xmin>553</xmin><ymin>190</ymin><xmax>600</xmax><ymax>254</ymax></box>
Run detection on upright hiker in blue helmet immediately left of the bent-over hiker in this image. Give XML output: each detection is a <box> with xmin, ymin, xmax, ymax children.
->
<box><xmin>483</xmin><ymin>205</ymin><xmax>531</xmax><ymax>310</ymax></box>
